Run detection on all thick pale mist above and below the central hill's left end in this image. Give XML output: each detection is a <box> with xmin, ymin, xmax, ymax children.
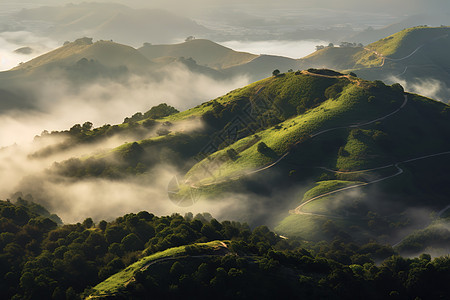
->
<box><xmin>0</xmin><ymin>65</ymin><xmax>248</xmax><ymax>222</ymax></box>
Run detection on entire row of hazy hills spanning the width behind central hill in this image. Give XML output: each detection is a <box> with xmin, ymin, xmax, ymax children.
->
<box><xmin>0</xmin><ymin>27</ymin><xmax>450</xmax><ymax>115</ymax></box>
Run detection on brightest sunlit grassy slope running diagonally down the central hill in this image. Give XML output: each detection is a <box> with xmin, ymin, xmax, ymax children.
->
<box><xmin>183</xmin><ymin>75</ymin><xmax>389</xmax><ymax>181</ymax></box>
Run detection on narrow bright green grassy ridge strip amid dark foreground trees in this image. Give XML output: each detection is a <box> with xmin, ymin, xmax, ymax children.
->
<box><xmin>92</xmin><ymin>241</ymin><xmax>222</xmax><ymax>298</ymax></box>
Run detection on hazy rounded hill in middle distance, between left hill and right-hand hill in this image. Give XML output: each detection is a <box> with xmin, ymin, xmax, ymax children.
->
<box><xmin>138</xmin><ymin>39</ymin><xmax>258</xmax><ymax>69</ymax></box>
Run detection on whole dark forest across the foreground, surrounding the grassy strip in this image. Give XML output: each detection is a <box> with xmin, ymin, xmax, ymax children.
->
<box><xmin>0</xmin><ymin>201</ymin><xmax>450</xmax><ymax>299</ymax></box>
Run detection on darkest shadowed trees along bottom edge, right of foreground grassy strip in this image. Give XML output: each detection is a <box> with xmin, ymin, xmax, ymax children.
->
<box><xmin>123</xmin><ymin>242</ymin><xmax>450</xmax><ymax>299</ymax></box>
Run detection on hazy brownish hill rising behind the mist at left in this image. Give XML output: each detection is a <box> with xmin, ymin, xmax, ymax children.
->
<box><xmin>0</xmin><ymin>37</ymin><xmax>227</xmax><ymax>114</ymax></box>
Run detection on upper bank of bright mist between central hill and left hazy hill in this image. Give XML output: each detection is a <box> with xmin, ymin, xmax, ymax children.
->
<box><xmin>0</xmin><ymin>64</ymin><xmax>249</xmax><ymax>146</ymax></box>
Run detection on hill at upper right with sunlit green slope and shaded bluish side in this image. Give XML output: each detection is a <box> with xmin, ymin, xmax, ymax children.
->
<box><xmin>299</xmin><ymin>26</ymin><xmax>450</xmax><ymax>101</ymax></box>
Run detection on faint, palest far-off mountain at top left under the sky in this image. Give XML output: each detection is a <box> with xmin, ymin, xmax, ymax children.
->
<box><xmin>10</xmin><ymin>2</ymin><xmax>210</xmax><ymax>45</ymax></box>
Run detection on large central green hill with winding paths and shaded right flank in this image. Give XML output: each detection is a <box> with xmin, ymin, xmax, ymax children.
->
<box><xmin>32</xmin><ymin>69</ymin><xmax>450</xmax><ymax>243</ymax></box>
